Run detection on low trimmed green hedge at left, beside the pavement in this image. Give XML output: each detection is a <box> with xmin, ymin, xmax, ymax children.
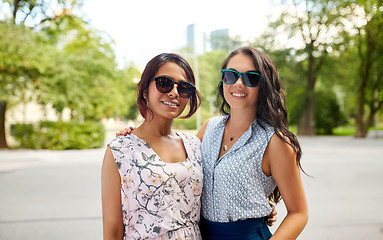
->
<box><xmin>13</xmin><ymin>121</ymin><xmax>105</xmax><ymax>150</ymax></box>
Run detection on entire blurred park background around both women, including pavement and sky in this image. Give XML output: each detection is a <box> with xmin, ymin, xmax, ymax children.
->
<box><xmin>0</xmin><ymin>0</ymin><xmax>383</xmax><ymax>240</ymax></box>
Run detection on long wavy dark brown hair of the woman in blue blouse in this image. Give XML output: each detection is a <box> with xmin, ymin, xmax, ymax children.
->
<box><xmin>218</xmin><ymin>47</ymin><xmax>303</xmax><ymax>203</ymax></box>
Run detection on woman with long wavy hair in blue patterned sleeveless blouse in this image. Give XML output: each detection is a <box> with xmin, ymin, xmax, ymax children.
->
<box><xmin>197</xmin><ymin>47</ymin><xmax>308</xmax><ymax>240</ymax></box>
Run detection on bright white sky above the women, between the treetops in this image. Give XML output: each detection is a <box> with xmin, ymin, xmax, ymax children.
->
<box><xmin>82</xmin><ymin>0</ymin><xmax>273</xmax><ymax>66</ymax></box>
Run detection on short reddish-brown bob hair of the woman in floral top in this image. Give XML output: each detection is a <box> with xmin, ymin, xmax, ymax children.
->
<box><xmin>137</xmin><ymin>53</ymin><xmax>201</xmax><ymax>118</ymax></box>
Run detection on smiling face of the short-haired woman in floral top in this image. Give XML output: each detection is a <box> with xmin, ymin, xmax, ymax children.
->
<box><xmin>147</xmin><ymin>62</ymin><xmax>189</xmax><ymax>119</ymax></box>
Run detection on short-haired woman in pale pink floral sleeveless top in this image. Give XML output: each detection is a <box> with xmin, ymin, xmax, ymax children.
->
<box><xmin>101</xmin><ymin>53</ymin><xmax>203</xmax><ymax>240</ymax></box>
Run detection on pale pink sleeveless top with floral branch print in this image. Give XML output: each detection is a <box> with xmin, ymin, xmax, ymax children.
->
<box><xmin>109</xmin><ymin>132</ymin><xmax>203</xmax><ymax>240</ymax></box>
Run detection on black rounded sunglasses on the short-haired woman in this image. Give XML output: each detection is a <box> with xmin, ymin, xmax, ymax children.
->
<box><xmin>154</xmin><ymin>76</ymin><xmax>195</xmax><ymax>98</ymax></box>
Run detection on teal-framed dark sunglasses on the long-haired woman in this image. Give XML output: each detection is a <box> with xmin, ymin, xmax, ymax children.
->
<box><xmin>221</xmin><ymin>69</ymin><xmax>262</xmax><ymax>87</ymax></box>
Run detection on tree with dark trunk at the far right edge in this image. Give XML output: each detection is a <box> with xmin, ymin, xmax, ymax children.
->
<box><xmin>346</xmin><ymin>0</ymin><xmax>383</xmax><ymax>138</ymax></box>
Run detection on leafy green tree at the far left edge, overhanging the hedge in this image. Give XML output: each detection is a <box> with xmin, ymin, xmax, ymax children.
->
<box><xmin>0</xmin><ymin>0</ymin><xmax>81</xmax><ymax>148</ymax></box>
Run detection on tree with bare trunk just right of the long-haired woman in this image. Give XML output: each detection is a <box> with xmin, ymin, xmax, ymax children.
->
<box><xmin>266</xmin><ymin>0</ymin><xmax>343</xmax><ymax>135</ymax></box>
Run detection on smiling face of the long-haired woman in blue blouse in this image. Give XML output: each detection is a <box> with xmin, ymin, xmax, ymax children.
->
<box><xmin>223</xmin><ymin>53</ymin><xmax>259</xmax><ymax>114</ymax></box>
